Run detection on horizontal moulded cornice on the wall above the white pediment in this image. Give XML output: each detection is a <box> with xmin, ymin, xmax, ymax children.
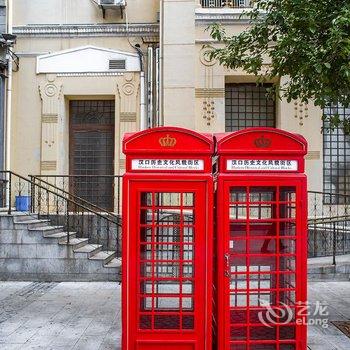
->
<box><xmin>13</xmin><ymin>23</ymin><xmax>159</xmax><ymax>38</ymax></box>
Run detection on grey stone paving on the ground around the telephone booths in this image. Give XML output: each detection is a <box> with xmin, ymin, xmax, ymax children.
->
<box><xmin>0</xmin><ymin>282</ymin><xmax>350</xmax><ymax>350</ymax></box>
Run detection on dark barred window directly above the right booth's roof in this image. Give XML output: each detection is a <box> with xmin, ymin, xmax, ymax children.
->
<box><xmin>225</xmin><ymin>83</ymin><xmax>276</xmax><ymax>131</ymax></box>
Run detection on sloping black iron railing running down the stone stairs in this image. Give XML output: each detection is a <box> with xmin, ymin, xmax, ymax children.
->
<box><xmin>0</xmin><ymin>171</ymin><xmax>121</xmax><ymax>256</ymax></box>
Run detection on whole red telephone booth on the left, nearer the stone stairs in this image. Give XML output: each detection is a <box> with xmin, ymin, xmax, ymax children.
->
<box><xmin>122</xmin><ymin>127</ymin><xmax>214</xmax><ymax>350</ymax></box>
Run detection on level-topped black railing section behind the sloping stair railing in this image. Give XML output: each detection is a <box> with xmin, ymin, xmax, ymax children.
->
<box><xmin>32</xmin><ymin>175</ymin><xmax>122</xmax><ymax>214</ymax></box>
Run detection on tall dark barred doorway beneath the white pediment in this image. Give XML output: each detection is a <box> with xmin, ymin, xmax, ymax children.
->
<box><xmin>69</xmin><ymin>100</ymin><xmax>115</xmax><ymax>211</ymax></box>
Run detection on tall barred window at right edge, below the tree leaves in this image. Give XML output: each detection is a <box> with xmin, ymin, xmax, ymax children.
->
<box><xmin>323</xmin><ymin>105</ymin><xmax>350</xmax><ymax>204</ymax></box>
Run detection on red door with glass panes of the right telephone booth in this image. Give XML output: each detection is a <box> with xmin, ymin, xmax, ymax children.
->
<box><xmin>218</xmin><ymin>176</ymin><xmax>306</xmax><ymax>350</ymax></box>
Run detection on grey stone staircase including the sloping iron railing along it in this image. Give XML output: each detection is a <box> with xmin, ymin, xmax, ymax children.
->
<box><xmin>0</xmin><ymin>172</ymin><xmax>121</xmax><ymax>282</ymax></box>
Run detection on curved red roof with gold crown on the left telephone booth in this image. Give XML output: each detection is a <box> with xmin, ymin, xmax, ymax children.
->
<box><xmin>123</xmin><ymin>126</ymin><xmax>214</xmax><ymax>156</ymax></box>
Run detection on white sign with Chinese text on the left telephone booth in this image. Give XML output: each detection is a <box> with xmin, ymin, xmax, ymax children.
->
<box><xmin>131</xmin><ymin>159</ymin><xmax>204</xmax><ymax>171</ymax></box>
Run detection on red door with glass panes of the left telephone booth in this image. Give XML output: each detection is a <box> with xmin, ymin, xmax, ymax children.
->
<box><xmin>124</xmin><ymin>177</ymin><xmax>211</xmax><ymax>350</ymax></box>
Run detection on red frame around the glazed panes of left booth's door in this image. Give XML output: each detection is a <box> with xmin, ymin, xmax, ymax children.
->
<box><xmin>123</xmin><ymin>179</ymin><xmax>212</xmax><ymax>350</ymax></box>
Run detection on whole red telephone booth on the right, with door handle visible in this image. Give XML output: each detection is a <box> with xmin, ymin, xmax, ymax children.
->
<box><xmin>216</xmin><ymin>128</ymin><xmax>307</xmax><ymax>350</ymax></box>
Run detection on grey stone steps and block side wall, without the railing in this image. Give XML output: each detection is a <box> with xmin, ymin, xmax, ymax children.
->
<box><xmin>0</xmin><ymin>209</ymin><xmax>121</xmax><ymax>281</ymax></box>
